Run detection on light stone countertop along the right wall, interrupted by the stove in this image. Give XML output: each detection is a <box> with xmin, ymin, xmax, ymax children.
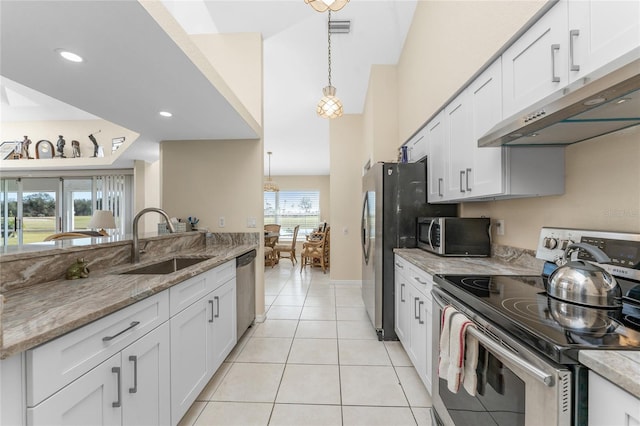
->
<box><xmin>394</xmin><ymin>249</ymin><xmax>640</xmax><ymax>398</ymax></box>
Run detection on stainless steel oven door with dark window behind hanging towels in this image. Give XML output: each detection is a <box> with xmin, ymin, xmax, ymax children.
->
<box><xmin>432</xmin><ymin>287</ymin><xmax>572</xmax><ymax>426</ymax></box>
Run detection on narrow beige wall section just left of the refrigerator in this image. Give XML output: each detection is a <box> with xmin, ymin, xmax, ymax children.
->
<box><xmin>329</xmin><ymin>115</ymin><xmax>364</xmax><ymax>281</ymax></box>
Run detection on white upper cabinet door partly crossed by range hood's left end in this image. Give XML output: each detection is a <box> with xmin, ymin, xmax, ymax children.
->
<box><xmin>466</xmin><ymin>59</ymin><xmax>504</xmax><ymax>197</ymax></box>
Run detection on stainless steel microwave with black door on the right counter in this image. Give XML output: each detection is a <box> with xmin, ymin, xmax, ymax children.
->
<box><xmin>416</xmin><ymin>217</ymin><xmax>491</xmax><ymax>256</ymax></box>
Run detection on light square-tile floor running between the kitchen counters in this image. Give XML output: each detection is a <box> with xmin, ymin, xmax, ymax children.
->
<box><xmin>180</xmin><ymin>260</ymin><xmax>431</xmax><ymax>426</ymax></box>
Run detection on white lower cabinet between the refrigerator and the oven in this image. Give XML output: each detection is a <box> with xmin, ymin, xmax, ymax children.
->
<box><xmin>395</xmin><ymin>256</ymin><xmax>433</xmax><ymax>392</ymax></box>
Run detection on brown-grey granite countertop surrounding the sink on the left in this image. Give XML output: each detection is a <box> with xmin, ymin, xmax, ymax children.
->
<box><xmin>0</xmin><ymin>243</ymin><xmax>258</xmax><ymax>359</ymax></box>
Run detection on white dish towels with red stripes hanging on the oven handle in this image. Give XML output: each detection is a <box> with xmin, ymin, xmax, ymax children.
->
<box><xmin>438</xmin><ymin>305</ymin><xmax>478</xmax><ymax>396</ymax></box>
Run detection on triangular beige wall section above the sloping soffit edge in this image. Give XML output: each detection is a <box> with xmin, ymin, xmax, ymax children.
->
<box><xmin>191</xmin><ymin>33</ymin><xmax>262</xmax><ymax>124</ymax></box>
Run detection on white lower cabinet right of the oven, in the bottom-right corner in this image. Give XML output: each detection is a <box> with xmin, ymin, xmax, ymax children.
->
<box><xmin>589</xmin><ymin>371</ymin><xmax>640</xmax><ymax>426</ymax></box>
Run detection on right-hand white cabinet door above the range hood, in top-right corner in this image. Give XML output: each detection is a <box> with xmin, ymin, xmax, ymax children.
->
<box><xmin>568</xmin><ymin>0</ymin><xmax>640</xmax><ymax>81</ymax></box>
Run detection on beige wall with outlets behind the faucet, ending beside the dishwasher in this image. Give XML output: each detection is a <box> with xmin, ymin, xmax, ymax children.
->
<box><xmin>160</xmin><ymin>140</ymin><xmax>264</xmax><ymax>315</ymax></box>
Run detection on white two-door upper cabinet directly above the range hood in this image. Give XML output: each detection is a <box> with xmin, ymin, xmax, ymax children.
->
<box><xmin>502</xmin><ymin>0</ymin><xmax>640</xmax><ymax>118</ymax></box>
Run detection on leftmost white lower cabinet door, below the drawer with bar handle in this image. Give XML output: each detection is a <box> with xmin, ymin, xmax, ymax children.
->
<box><xmin>27</xmin><ymin>353</ymin><xmax>123</xmax><ymax>426</ymax></box>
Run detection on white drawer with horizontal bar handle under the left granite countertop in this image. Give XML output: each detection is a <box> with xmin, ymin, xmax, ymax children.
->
<box><xmin>27</xmin><ymin>291</ymin><xmax>169</xmax><ymax>407</ymax></box>
